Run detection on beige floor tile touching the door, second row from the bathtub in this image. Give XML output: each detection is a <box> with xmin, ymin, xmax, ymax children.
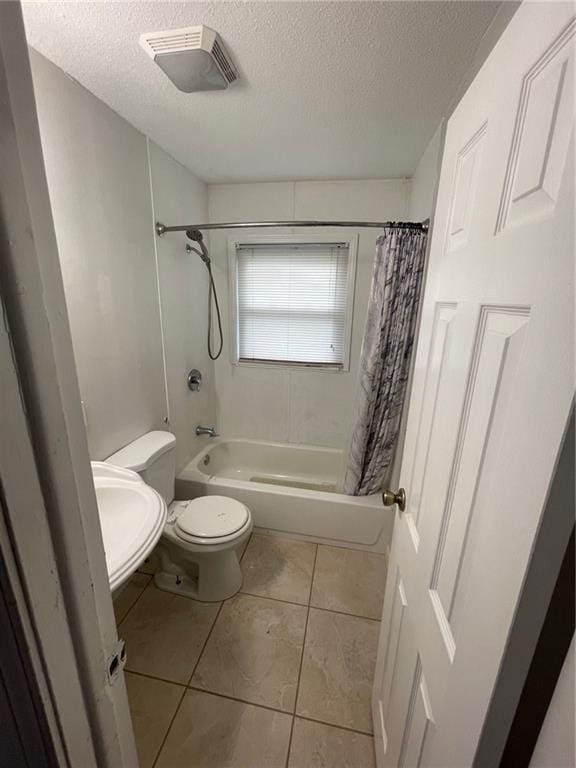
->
<box><xmin>296</xmin><ymin>608</ymin><xmax>380</xmax><ymax>733</ymax></box>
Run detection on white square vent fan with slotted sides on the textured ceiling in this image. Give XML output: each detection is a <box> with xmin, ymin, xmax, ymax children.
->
<box><xmin>140</xmin><ymin>26</ymin><xmax>238</xmax><ymax>93</ymax></box>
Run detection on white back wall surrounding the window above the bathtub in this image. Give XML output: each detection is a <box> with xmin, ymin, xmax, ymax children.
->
<box><xmin>209</xmin><ymin>179</ymin><xmax>410</xmax><ymax>448</ymax></box>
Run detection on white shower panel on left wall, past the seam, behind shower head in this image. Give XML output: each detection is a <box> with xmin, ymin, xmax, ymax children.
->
<box><xmin>150</xmin><ymin>141</ymin><xmax>216</xmax><ymax>469</ymax></box>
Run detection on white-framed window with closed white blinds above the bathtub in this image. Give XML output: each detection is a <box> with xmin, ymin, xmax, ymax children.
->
<box><xmin>231</xmin><ymin>235</ymin><xmax>355</xmax><ymax>370</ymax></box>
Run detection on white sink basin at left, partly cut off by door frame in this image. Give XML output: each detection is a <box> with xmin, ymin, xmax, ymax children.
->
<box><xmin>91</xmin><ymin>461</ymin><xmax>168</xmax><ymax>591</ymax></box>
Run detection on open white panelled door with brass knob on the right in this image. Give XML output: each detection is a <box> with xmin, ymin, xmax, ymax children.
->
<box><xmin>373</xmin><ymin>2</ymin><xmax>575</xmax><ymax>768</ymax></box>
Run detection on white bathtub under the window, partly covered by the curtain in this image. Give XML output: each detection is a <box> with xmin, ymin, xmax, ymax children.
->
<box><xmin>176</xmin><ymin>438</ymin><xmax>394</xmax><ymax>552</ymax></box>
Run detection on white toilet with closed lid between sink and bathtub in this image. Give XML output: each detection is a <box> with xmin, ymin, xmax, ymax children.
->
<box><xmin>106</xmin><ymin>431</ymin><xmax>252</xmax><ymax>602</ymax></box>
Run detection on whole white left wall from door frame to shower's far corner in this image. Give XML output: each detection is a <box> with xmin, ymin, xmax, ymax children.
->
<box><xmin>30</xmin><ymin>50</ymin><xmax>213</xmax><ymax>466</ymax></box>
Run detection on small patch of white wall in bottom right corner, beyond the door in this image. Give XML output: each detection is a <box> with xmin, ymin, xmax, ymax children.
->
<box><xmin>530</xmin><ymin>638</ymin><xmax>575</xmax><ymax>768</ymax></box>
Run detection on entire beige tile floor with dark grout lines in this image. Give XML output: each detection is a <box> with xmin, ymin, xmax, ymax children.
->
<box><xmin>114</xmin><ymin>533</ymin><xmax>386</xmax><ymax>768</ymax></box>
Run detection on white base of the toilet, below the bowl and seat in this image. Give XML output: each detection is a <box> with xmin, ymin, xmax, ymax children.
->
<box><xmin>154</xmin><ymin>543</ymin><xmax>242</xmax><ymax>603</ymax></box>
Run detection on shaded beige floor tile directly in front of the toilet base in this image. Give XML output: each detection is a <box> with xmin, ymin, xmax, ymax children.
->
<box><xmin>120</xmin><ymin>583</ymin><xmax>220</xmax><ymax>683</ymax></box>
